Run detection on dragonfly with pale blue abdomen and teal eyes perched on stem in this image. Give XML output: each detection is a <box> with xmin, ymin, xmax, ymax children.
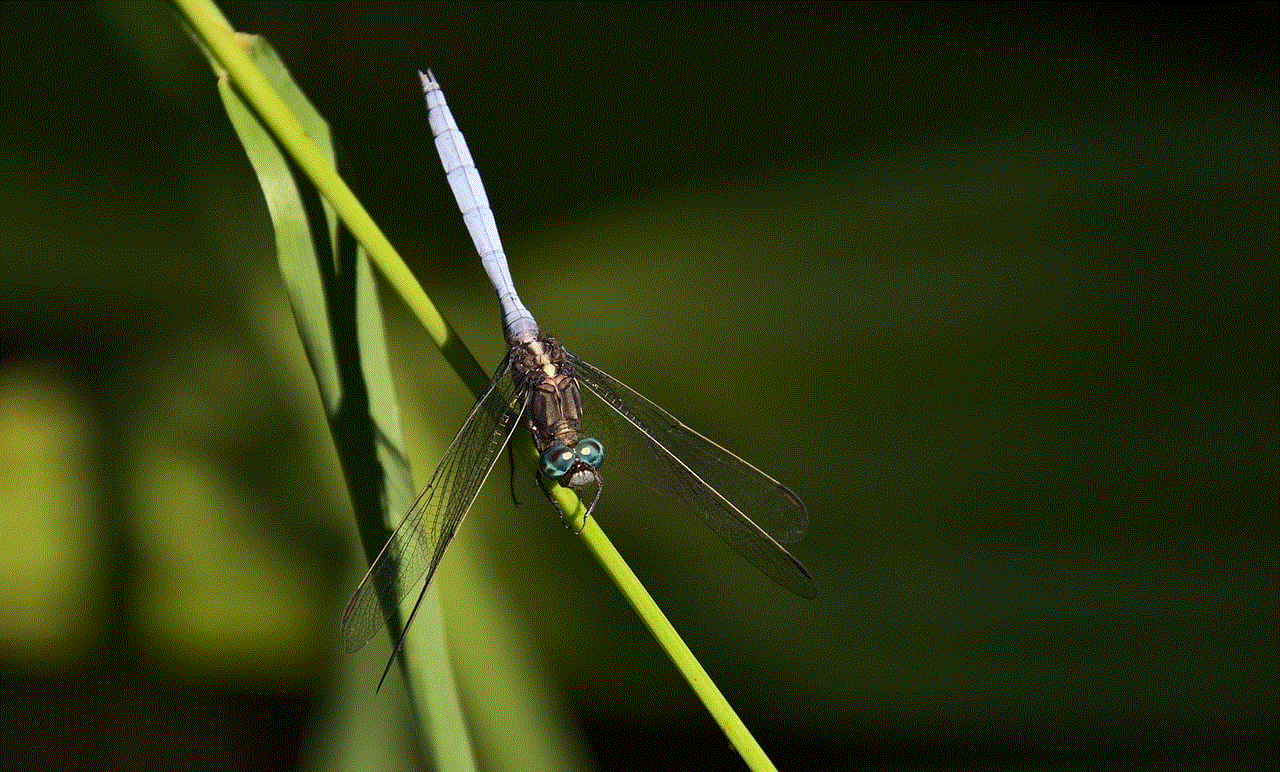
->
<box><xmin>342</xmin><ymin>70</ymin><xmax>815</xmax><ymax>689</ymax></box>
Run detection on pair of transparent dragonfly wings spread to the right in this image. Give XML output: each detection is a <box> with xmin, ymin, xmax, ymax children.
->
<box><xmin>570</xmin><ymin>355</ymin><xmax>815</xmax><ymax>598</ymax></box>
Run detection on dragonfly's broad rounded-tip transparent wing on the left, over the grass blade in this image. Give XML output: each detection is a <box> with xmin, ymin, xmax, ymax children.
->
<box><xmin>342</xmin><ymin>357</ymin><xmax>526</xmax><ymax>652</ymax></box>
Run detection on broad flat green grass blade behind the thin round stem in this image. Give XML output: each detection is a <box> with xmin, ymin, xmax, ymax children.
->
<box><xmin>194</xmin><ymin>21</ymin><xmax>475</xmax><ymax>772</ymax></box>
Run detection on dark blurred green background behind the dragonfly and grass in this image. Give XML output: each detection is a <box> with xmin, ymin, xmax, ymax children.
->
<box><xmin>0</xmin><ymin>3</ymin><xmax>1280</xmax><ymax>769</ymax></box>
